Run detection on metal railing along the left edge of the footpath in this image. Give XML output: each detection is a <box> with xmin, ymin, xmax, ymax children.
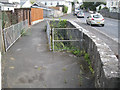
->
<box><xmin>3</xmin><ymin>20</ymin><xmax>28</xmax><ymax>51</ymax></box>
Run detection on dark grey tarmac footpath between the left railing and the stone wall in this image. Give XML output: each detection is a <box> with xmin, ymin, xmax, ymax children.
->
<box><xmin>2</xmin><ymin>21</ymin><xmax>94</xmax><ymax>88</ymax></box>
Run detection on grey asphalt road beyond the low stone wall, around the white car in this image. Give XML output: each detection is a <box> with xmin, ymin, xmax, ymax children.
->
<box><xmin>62</xmin><ymin>12</ymin><xmax>120</xmax><ymax>55</ymax></box>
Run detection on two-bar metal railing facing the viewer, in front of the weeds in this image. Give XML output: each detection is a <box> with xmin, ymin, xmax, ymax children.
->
<box><xmin>52</xmin><ymin>28</ymin><xmax>83</xmax><ymax>51</ymax></box>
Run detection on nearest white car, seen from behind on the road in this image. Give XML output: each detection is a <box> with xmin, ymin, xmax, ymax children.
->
<box><xmin>86</xmin><ymin>13</ymin><xmax>104</xmax><ymax>26</ymax></box>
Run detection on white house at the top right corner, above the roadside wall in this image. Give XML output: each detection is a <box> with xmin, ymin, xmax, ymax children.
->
<box><xmin>106</xmin><ymin>0</ymin><xmax>120</xmax><ymax>12</ymax></box>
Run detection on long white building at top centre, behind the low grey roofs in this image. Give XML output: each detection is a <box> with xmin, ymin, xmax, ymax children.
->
<box><xmin>36</xmin><ymin>0</ymin><xmax>72</xmax><ymax>13</ymax></box>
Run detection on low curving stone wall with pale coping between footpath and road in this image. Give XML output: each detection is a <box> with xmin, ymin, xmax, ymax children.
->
<box><xmin>69</xmin><ymin>21</ymin><xmax>120</xmax><ymax>88</ymax></box>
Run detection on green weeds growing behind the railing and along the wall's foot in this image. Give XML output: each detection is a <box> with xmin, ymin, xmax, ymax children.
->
<box><xmin>51</xmin><ymin>19</ymin><xmax>94</xmax><ymax>74</ymax></box>
